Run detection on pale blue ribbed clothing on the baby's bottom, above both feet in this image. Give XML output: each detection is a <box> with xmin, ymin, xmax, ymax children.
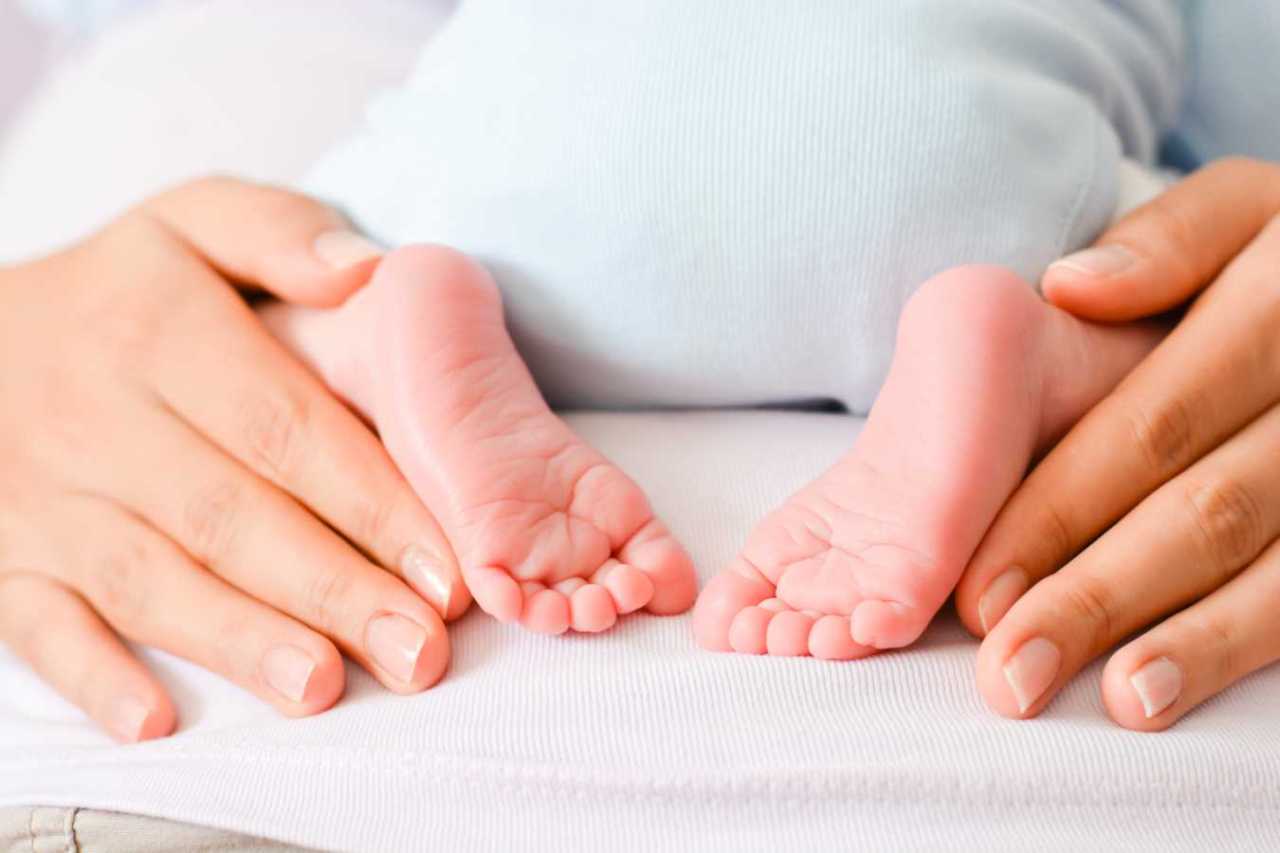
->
<box><xmin>306</xmin><ymin>0</ymin><xmax>1183</xmax><ymax>411</ymax></box>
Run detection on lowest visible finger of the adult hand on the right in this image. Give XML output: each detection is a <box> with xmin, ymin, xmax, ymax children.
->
<box><xmin>1102</xmin><ymin>543</ymin><xmax>1280</xmax><ymax>731</ymax></box>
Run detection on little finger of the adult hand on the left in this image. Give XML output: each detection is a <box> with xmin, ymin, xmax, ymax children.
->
<box><xmin>0</xmin><ymin>573</ymin><xmax>177</xmax><ymax>743</ymax></box>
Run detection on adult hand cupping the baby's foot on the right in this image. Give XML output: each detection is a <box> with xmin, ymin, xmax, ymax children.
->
<box><xmin>956</xmin><ymin>160</ymin><xmax>1280</xmax><ymax>731</ymax></box>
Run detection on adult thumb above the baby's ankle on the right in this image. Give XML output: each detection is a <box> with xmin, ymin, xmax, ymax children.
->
<box><xmin>1041</xmin><ymin>158</ymin><xmax>1280</xmax><ymax>321</ymax></box>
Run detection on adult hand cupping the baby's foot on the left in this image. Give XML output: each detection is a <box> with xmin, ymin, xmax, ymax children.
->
<box><xmin>0</xmin><ymin>179</ymin><xmax>468</xmax><ymax>740</ymax></box>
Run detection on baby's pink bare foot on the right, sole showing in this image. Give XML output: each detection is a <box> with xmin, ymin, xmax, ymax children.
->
<box><xmin>694</xmin><ymin>268</ymin><xmax>1160</xmax><ymax>660</ymax></box>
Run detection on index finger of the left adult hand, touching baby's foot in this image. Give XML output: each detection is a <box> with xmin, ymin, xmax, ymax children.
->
<box><xmin>133</xmin><ymin>227</ymin><xmax>470</xmax><ymax>619</ymax></box>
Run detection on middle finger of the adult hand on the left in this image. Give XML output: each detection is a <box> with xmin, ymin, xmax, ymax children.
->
<box><xmin>93</xmin><ymin>404</ymin><xmax>449</xmax><ymax>693</ymax></box>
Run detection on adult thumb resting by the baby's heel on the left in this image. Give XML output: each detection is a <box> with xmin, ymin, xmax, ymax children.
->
<box><xmin>136</xmin><ymin>177</ymin><xmax>383</xmax><ymax>307</ymax></box>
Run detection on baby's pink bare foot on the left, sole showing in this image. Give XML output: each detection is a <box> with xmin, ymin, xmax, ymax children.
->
<box><xmin>266</xmin><ymin>246</ymin><xmax>696</xmax><ymax>634</ymax></box>
